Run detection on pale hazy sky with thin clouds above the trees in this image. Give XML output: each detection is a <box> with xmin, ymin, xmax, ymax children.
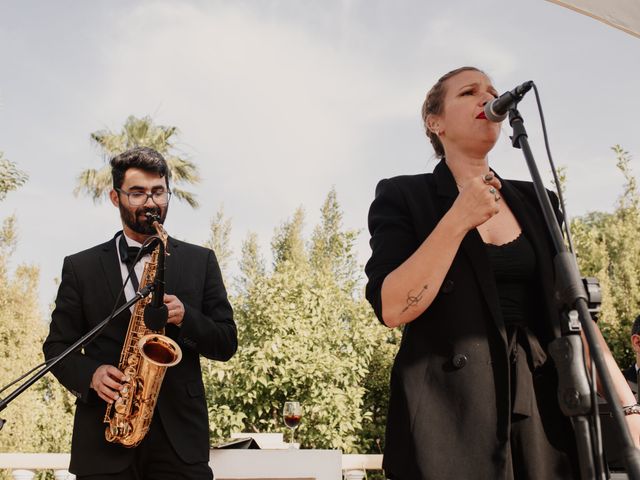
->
<box><xmin>0</xmin><ymin>0</ymin><xmax>640</xmax><ymax>319</ymax></box>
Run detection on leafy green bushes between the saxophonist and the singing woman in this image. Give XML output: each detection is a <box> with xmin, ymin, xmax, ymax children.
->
<box><xmin>205</xmin><ymin>191</ymin><xmax>395</xmax><ymax>453</ymax></box>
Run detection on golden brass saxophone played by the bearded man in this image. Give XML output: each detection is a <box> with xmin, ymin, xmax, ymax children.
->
<box><xmin>104</xmin><ymin>221</ymin><xmax>182</xmax><ymax>447</ymax></box>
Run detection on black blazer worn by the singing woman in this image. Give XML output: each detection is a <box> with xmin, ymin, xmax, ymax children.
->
<box><xmin>366</xmin><ymin>161</ymin><xmax>572</xmax><ymax>480</ymax></box>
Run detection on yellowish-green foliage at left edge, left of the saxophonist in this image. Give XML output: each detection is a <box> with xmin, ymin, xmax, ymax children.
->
<box><xmin>0</xmin><ymin>217</ymin><xmax>73</xmax><ymax>452</ymax></box>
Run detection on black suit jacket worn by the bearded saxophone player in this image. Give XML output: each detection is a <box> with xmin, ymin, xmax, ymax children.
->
<box><xmin>43</xmin><ymin>233</ymin><xmax>237</xmax><ymax>475</ymax></box>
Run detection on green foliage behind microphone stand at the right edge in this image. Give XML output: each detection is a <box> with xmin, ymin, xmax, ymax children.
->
<box><xmin>571</xmin><ymin>145</ymin><xmax>640</xmax><ymax>366</ymax></box>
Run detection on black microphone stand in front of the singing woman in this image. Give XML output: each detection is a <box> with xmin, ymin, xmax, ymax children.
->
<box><xmin>509</xmin><ymin>106</ymin><xmax>640</xmax><ymax>480</ymax></box>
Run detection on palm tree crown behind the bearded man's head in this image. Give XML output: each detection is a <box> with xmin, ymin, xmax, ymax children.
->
<box><xmin>73</xmin><ymin>115</ymin><xmax>200</xmax><ymax>208</ymax></box>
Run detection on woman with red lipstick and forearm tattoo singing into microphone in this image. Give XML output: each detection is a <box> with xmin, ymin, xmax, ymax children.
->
<box><xmin>366</xmin><ymin>67</ymin><xmax>640</xmax><ymax>480</ymax></box>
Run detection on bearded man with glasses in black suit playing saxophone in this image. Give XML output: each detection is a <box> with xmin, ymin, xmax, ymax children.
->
<box><xmin>43</xmin><ymin>147</ymin><xmax>237</xmax><ymax>480</ymax></box>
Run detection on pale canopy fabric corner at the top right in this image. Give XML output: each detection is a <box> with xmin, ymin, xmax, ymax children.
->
<box><xmin>547</xmin><ymin>0</ymin><xmax>640</xmax><ymax>38</ymax></box>
